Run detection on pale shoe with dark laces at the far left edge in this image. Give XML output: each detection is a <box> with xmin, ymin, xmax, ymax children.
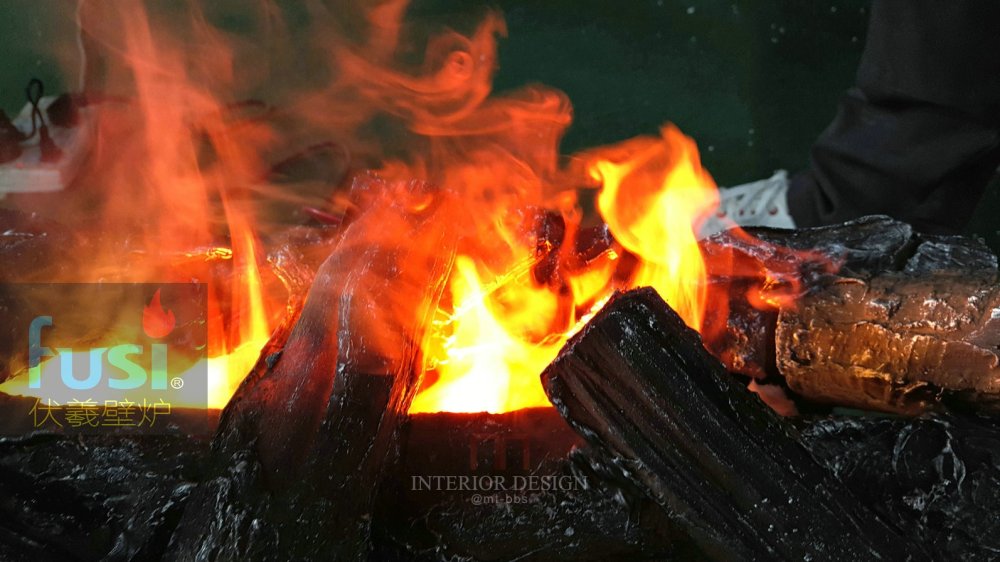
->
<box><xmin>0</xmin><ymin>84</ymin><xmax>94</xmax><ymax>199</ymax></box>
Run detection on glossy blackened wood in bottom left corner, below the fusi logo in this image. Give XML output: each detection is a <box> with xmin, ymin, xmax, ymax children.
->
<box><xmin>0</xmin><ymin>432</ymin><xmax>209</xmax><ymax>562</ymax></box>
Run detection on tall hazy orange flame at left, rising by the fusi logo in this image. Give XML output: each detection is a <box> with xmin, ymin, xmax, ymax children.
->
<box><xmin>0</xmin><ymin>2</ymin><xmax>282</xmax><ymax>408</ymax></box>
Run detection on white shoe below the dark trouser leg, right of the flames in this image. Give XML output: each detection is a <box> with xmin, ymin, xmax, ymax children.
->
<box><xmin>698</xmin><ymin>166</ymin><xmax>795</xmax><ymax>239</ymax></box>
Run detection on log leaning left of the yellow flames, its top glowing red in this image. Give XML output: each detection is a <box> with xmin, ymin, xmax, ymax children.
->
<box><xmin>170</xmin><ymin>173</ymin><xmax>455</xmax><ymax>562</ymax></box>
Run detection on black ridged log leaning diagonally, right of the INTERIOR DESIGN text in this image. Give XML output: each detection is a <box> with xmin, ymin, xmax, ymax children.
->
<box><xmin>542</xmin><ymin>288</ymin><xmax>927</xmax><ymax>560</ymax></box>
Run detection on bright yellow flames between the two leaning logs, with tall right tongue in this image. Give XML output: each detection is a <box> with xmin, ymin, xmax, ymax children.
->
<box><xmin>410</xmin><ymin>126</ymin><xmax>718</xmax><ymax>413</ymax></box>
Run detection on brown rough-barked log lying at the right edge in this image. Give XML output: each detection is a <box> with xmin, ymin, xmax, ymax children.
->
<box><xmin>775</xmin><ymin>272</ymin><xmax>1000</xmax><ymax>415</ymax></box>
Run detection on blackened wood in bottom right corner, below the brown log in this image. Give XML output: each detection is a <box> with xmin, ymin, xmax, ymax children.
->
<box><xmin>802</xmin><ymin>414</ymin><xmax>1000</xmax><ymax>560</ymax></box>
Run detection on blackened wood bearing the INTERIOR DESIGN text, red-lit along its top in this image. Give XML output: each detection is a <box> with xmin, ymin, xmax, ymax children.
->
<box><xmin>373</xmin><ymin>408</ymin><xmax>696</xmax><ymax>562</ymax></box>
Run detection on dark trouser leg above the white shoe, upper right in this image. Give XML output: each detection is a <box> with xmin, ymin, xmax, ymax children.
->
<box><xmin>789</xmin><ymin>0</ymin><xmax>1000</xmax><ymax>233</ymax></box>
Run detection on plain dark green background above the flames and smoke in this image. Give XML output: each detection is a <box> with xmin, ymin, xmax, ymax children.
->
<box><xmin>0</xmin><ymin>0</ymin><xmax>1000</xmax><ymax>247</ymax></box>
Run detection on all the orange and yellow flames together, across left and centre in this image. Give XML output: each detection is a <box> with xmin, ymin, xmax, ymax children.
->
<box><xmin>0</xmin><ymin>0</ymin><xmax>800</xmax><ymax>412</ymax></box>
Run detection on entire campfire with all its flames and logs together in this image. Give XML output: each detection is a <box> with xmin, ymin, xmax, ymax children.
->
<box><xmin>0</xmin><ymin>0</ymin><xmax>1000</xmax><ymax>560</ymax></box>
